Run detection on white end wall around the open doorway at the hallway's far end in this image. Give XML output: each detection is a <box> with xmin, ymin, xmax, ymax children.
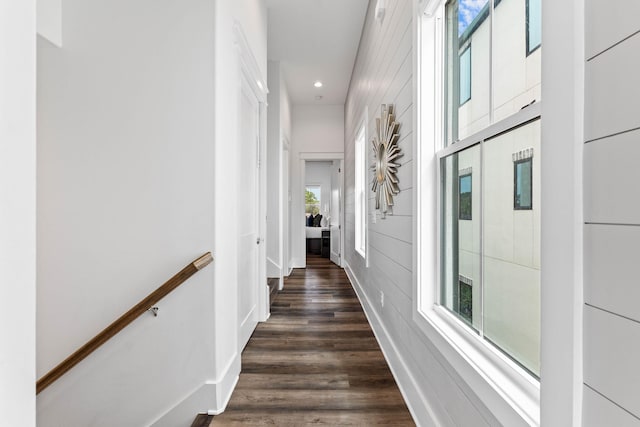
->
<box><xmin>289</xmin><ymin>105</ymin><xmax>344</xmax><ymax>268</ymax></box>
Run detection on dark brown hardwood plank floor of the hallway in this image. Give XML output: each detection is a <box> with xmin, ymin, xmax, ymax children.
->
<box><xmin>211</xmin><ymin>257</ymin><xmax>415</xmax><ymax>426</ymax></box>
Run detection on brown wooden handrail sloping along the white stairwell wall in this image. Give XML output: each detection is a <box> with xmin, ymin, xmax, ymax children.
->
<box><xmin>36</xmin><ymin>252</ymin><xmax>213</xmax><ymax>394</ymax></box>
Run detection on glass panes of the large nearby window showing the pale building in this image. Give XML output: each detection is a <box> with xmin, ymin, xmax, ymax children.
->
<box><xmin>437</xmin><ymin>0</ymin><xmax>541</xmax><ymax>376</ymax></box>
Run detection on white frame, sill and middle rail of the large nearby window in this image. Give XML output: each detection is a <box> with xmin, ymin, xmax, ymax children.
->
<box><xmin>413</xmin><ymin>0</ymin><xmax>542</xmax><ymax>425</ymax></box>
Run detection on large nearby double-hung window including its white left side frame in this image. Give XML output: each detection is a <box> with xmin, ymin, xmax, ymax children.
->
<box><xmin>417</xmin><ymin>0</ymin><xmax>542</xmax><ymax>402</ymax></box>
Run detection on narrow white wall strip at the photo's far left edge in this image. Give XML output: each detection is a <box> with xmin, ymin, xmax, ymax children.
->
<box><xmin>0</xmin><ymin>0</ymin><xmax>36</xmax><ymax>427</ymax></box>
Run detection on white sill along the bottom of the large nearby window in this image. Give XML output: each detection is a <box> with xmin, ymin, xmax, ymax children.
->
<box><xmin>414</xmin><ymin>306</ymin><xmax>540</xmax><ymax>426</ymax></box>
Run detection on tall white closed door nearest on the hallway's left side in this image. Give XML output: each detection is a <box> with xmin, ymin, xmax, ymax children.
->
<box><xmin>236</xmin><ymin>76</ymin><xmax>260</xmax><ymax>351</ymax></box>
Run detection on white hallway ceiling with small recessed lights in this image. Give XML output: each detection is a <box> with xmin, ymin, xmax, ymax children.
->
<box><xmin>266</xmin><ymin>0</ymin><xmax>369</xmax><ymax>105</ymax></box>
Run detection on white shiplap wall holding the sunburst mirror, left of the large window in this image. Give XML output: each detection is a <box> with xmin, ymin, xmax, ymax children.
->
<box><xmin>344</xmin><ymin>0</ymin><xmax>499</xmax><ymax>426</ymax></box>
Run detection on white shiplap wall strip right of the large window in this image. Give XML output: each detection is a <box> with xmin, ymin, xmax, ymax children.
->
<box><xmin>583</xmin><ymin>0</ymin><xmax>640</xmax><ymax>426</ymax></box>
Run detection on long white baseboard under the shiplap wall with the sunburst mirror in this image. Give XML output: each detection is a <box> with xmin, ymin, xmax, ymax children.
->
<box><xmin>344</xmin><ymin>260</ymin><xmax>440</xmax><ymax>426</ymax></box>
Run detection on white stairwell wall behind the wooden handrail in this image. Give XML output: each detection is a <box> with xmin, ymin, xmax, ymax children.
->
<box><xmin>37</xmin><ymin>0</ymin><xmax>266</xmax><ymax>426</ymax></box>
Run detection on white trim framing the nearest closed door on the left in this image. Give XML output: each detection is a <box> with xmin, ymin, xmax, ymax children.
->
<box><xmin>233</xmin><ymin>22</ymin><xmax>270</xmax><ymax>328</ymax></box>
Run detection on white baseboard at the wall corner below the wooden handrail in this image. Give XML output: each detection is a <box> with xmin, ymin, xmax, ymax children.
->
<box><xmin>151</xmin><ymin>354</ymin><xmax>240</xmax><ymax>427</ymax></box>
